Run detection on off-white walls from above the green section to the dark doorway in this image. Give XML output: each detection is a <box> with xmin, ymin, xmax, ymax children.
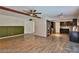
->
<box><xmin>0</xmin><ymin>14</ymin><xmax>47</xmax><ymax>37</ymax></box>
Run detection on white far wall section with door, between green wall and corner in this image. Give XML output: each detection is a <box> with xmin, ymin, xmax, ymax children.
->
<box><xmin>24</xmin><ymin>16</ymin><xmax>35</xmax><ymax>34</ymax></box>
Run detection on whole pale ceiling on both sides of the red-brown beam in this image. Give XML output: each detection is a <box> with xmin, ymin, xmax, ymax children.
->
<box><xmin>0</xmin><ymin>6</ymin><xmax>79</xmax><ymax>19</ymax></box>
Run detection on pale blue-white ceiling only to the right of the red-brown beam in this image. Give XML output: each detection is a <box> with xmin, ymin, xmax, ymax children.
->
<box><xmin>7</xmin><ymin>6</ymin><xmax>79</xmax><ymax>18</ymax></box>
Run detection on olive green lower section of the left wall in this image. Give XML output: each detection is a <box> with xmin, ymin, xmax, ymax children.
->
<box><xmin>0</xmin><ymin>26</ymin><xmax>24</xmax><ymax>37</ymax></box>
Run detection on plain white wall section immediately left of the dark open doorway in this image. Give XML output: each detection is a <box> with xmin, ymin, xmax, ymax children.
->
<box><xmin>35</xmin><ymin>19</ymin><xmax>47</xmax><ymax>37</ymax></box>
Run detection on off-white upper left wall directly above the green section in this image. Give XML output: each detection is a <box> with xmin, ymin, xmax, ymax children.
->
<box><xmin>0</xmin><ymin>14</ymin><xmax>25</xmax><ymax>26</ymax></box>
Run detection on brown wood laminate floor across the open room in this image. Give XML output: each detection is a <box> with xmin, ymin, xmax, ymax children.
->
<box><xmin>0</xmin><ymin>34</ymin><xmax>78</xmax><ymax>53</ymax></box>
